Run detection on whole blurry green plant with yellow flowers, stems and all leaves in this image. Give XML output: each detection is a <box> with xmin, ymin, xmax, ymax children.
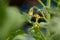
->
<box><xmin>0</xmin><ymin>0</ymin><xmax>60</xmax><ymax>40</ymax></box>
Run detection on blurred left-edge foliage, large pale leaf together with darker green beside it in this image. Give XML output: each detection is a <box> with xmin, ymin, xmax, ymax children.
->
<box><xmin>0</xmin><ymin>0</ymin><xmax>26</xmax><ymax>40</ymax></box>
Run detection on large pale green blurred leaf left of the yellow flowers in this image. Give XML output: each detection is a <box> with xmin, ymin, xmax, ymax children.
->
<box><xmin>0</xmin><ymin>7</ymin><xmax>26</xmax><ymax>40</ymax></box>
